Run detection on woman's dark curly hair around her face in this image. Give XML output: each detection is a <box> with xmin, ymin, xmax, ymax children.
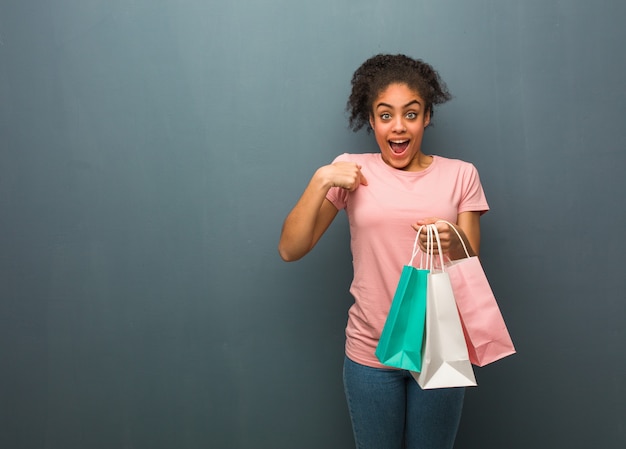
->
<box><xmin>346</xmin><ymin>54</ymin><xmax>452</xmax><ymax>132</ymax></box>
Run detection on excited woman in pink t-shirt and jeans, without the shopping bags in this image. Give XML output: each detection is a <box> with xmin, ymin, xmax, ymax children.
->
<box><xmin>279</xmin><ymin>55</ymin><xmax>489</xmax><ymax>449</ymax></box>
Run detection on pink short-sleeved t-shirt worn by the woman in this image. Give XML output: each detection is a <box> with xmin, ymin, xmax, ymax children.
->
<box><xmin>326</xmin><ymin>153</ymin><xmax>489</xmax><ymax>367</ymax></box>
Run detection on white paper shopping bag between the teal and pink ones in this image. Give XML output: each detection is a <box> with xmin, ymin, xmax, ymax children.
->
<box><xmin>411</xmin><ymin>225</ymin><xmax>476</xmax><ymax>389</ymax></box>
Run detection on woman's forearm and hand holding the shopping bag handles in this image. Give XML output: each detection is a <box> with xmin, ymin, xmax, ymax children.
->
<box><xmin>413</xmin><ymin>212</ymin><xmax>480</xmax><ymax>260</ymax></box>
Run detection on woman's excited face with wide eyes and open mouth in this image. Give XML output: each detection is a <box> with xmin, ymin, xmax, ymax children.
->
<box><xmin>370</xmin><ymin>84</ymin><xmax>430</xmax><ymax>171</ymax></box>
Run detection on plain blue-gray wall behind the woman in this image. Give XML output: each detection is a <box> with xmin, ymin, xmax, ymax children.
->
<box><xmin>0</xmin><ymin>0</ymin><xmax>626</xmax><ymax>449</ymax></box>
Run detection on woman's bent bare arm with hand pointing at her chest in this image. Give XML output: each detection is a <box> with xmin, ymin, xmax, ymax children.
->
<box><xmin>278</xmin><ymin>162</ymin><xmax>367</xmax><ymax>262</ymax></box>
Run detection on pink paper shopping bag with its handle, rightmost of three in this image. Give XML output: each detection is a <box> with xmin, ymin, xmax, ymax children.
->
<box><xmin>436</xmin><ymin>222</ymin><xmax>515</xmax><ymax>366</ymax></box>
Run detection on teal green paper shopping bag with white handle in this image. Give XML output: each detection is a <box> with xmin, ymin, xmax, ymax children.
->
<box><xmin>375</xmin><ymin>231</ymin><xmax>428</xmax><ymax>372</ymax></box>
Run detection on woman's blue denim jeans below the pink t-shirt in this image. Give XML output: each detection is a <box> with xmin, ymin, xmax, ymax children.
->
<box><xmin>343</xmin><ymin>357</ymin><xmax>465</xmax><ymax>449</ymax></box>
